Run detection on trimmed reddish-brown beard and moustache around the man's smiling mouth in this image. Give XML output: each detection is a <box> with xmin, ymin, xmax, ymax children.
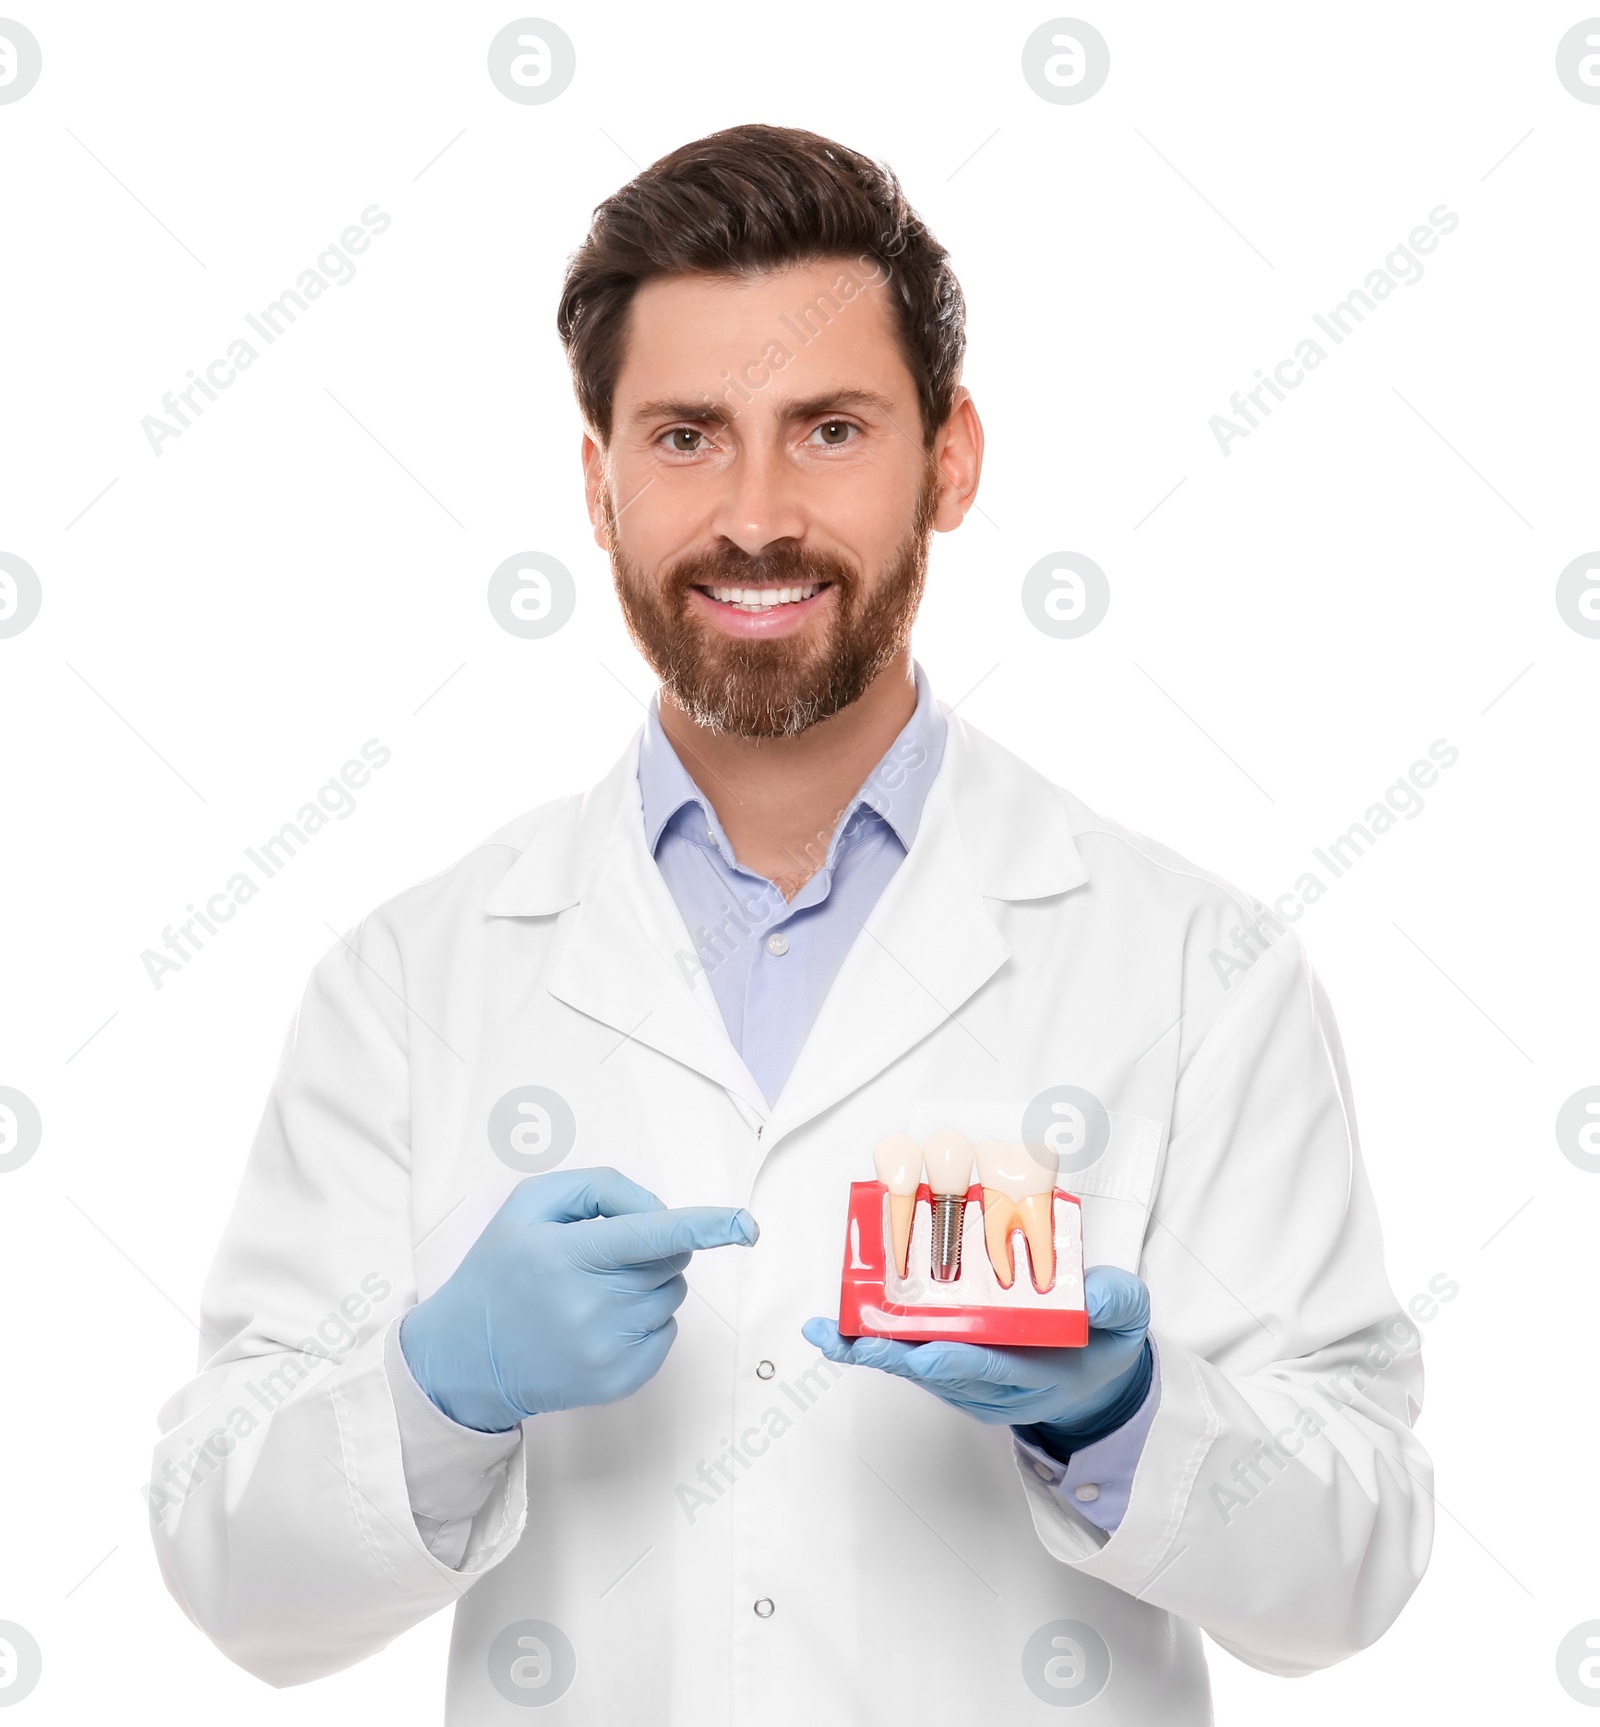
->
<box><xmin>605</xmin><ymin>468</ymin><xmax>938</xmax><ymax>737</ymax></box>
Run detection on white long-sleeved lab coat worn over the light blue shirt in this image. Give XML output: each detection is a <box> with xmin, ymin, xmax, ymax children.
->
<box><xmin>152</xmin><ymin>717</ymin><xmax>1432</xmax><ymax>1727</ymax></box>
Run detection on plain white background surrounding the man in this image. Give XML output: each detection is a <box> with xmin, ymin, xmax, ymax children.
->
<box><xmin>0</xmin><ymin>0</ymin><xmax>1600</xmax><ymax>1727</ymax></box>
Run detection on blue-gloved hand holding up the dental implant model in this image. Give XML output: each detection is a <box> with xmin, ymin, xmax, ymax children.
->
<box><xmin>800</xmin><ymin>1266</ymin><xmax>1151</xmax><ymax>1449</ymax></box>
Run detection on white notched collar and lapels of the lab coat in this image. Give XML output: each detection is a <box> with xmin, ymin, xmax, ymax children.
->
<box><xmin>484</xmin><ymin>715</ymin><xmax>1089</xmax><ymax>1150</ymax></box>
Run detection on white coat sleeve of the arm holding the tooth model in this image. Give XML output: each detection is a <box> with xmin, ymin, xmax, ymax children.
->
<box><xmin>1021</xmin><ymin>931</ymin><xmax>1432</xmax><ymax>1675</ymax></box>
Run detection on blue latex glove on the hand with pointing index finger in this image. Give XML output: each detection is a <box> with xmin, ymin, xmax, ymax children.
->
<box><xmin>399</xmin><ymin>1169</ymin><xmax>760</xmax><ymax>1433</ymax></box>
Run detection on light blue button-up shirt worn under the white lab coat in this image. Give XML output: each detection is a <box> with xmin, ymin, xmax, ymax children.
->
<box><xmin>639</xmin><ymin>667</ymin><xmax>1161</xmax><ymax>1534</ymax></box>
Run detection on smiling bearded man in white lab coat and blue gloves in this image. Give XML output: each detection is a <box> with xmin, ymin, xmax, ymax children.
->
<box><xmin>150</xmin><ymin>126</ymin><xmax>1432</xmax><ymax>1727</ymax></box>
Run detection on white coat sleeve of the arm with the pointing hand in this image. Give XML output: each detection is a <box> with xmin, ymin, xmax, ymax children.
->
<box><xmin>147</xmin><ymin>919</ymin><xmax>525</xmax><ymax>1686</ymax></box>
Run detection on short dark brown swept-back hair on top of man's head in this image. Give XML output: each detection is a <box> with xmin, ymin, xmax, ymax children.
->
<box><xmin>556</xmin><ymin>126</ymin><xmax>966</xmax><ymax>444</ymax></box>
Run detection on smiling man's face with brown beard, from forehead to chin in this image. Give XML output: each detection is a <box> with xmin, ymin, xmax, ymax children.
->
<box><xmin>584</xmin><ymin>259</ymin><xmax>964</xmax><ymax>737</ymax></box>
